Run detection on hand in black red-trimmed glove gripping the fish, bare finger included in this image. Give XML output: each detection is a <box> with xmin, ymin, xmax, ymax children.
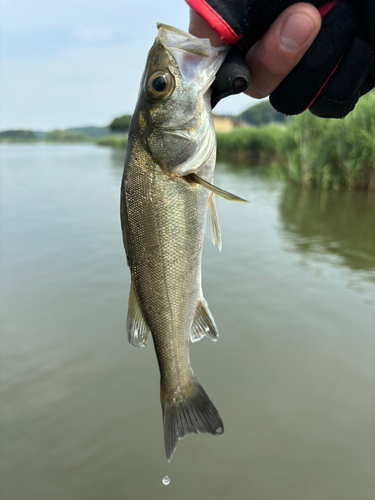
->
<box><xmin>186</xmin><ymin>0</ymin><xmax>375</xmax><ymax>118</ymax></box>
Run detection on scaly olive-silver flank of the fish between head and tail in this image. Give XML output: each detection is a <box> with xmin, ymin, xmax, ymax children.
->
<box><xmin>124</xmin><ymin>139</ymin><xmax>209</xmax><ymax>386</ymax></box>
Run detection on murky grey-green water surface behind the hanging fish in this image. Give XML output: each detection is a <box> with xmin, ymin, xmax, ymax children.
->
<box><xmin>0</xmin><ymin>145</ymin><xmax>375</xmax><ymax>500</ymax></box>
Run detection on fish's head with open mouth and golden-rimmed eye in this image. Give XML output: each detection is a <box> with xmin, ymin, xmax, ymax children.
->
<box><xmin>135</xmin><ymin>24</ymin><xmax>228</xmax><ymax>176</ymax></box>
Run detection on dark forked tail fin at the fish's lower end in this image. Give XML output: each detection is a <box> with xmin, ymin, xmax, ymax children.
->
<box><xmin>162</xmin><ymin>380</ymin><xmax>224</xmax><ymax>462</ymax></box>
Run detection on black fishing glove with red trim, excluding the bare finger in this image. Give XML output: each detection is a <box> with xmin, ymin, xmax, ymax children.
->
<box><xmin>186</xmin><ymin>0</ymin><xmax>375</xmax><ymax>118</ymax></box>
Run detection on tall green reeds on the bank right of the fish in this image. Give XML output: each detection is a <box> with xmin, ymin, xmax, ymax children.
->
<box><xmin>217</xmin><ymin>92</ymin><xmax>375</xmax><ymax>190</ymax></box>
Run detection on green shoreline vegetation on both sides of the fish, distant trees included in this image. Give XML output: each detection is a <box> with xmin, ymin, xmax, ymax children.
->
<box><xmin>0</xmin><ymin>92</ymin><xmax>375</xmax><ymax>191</ymax></box>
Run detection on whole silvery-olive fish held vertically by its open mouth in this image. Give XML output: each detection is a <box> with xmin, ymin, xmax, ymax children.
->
<box><xmin>121</xmin><ymin>24</ymin><xmax>245</xmax><ymax>461</ymax></box>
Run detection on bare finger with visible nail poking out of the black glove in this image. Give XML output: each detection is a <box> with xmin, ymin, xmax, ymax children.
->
<box><xmin>245</xmin><ymin>3</ymin><xmax>321</xmax><ymax>99</ymax></box>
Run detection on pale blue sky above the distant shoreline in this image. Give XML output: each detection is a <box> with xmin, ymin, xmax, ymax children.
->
<box><xmin>0</xmin><ymin>0</ymin><xmax>257</xmax><ymax>130</ymax></box>
